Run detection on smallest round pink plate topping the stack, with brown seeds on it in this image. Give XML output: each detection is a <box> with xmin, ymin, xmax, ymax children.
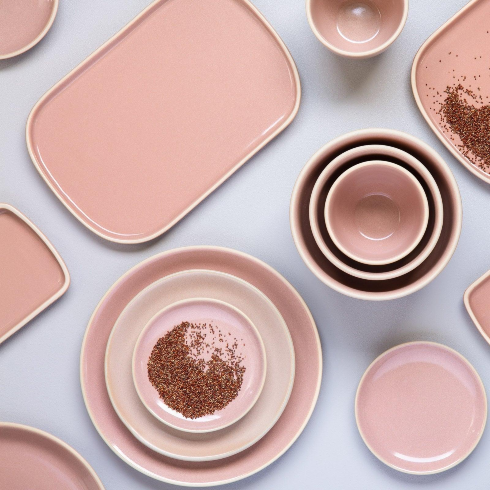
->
<box><xmin>133</xmin><ymin>298</ymin><xmax>266</xmax><ymax>433</ymax></box>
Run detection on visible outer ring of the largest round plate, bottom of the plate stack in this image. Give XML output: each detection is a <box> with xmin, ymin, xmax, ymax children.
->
<box><xmin>80</xmin><ymin>247</ymin><xmax>322</xmax><ymax>486</ymax></box>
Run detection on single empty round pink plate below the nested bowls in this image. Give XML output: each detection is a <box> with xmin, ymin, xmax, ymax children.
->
<box><xmin>355</xmin><ymin>342</ymin><xmax>487</xmax><ymax>475</ymax></box>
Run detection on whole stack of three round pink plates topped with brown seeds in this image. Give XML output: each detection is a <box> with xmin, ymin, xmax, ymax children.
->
<box><xmin>81</xmin><ymin>247</ymin><xmax>321</xmax><ymax>486</ymax></box>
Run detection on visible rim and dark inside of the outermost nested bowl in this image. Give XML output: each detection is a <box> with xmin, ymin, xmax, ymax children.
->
<box><xmin>290</xmin><ymin>129</ymin><xmax>462</xmax><ymax>300</ymax></box>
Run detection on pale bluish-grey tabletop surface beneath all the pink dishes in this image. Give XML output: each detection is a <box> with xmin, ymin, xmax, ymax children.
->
<box><xmin>0</xmin><ymin>0</ymin><xmax>490</xmax><ymax>490</ymax></box>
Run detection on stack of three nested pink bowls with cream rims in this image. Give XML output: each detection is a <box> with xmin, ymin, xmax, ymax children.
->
<box><xmin>291</xmin><ymin>129</ymin><xmax>462</xmax><ymax>300</ymax></box>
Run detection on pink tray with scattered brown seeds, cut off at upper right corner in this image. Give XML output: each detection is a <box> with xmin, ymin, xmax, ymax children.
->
<box><xmin>412</xmin><ymin>0</ymin><xmax>490</xmax><ymax>183</ymax></box>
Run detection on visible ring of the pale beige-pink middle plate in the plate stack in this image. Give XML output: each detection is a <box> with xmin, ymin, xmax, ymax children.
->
<box><xmin>105</xmin><ymin>270</ymin><xmax>295</xmax><ymax>462</ymax></box>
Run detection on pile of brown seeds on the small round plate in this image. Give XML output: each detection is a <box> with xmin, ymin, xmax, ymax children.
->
<box><xmin>147</xmin><ymin>322</ymin><xmax>246</xmax><ymax>419</ymax></box>
